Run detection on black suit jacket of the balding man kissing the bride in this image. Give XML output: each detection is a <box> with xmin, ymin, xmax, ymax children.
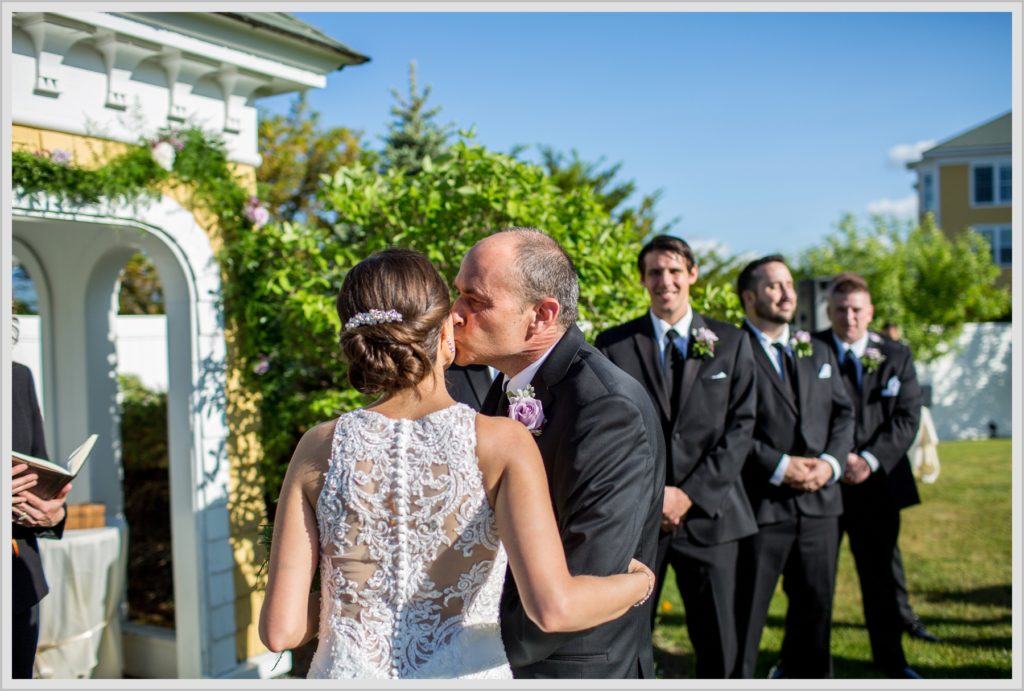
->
<box><xmin>483</xmin><ymin>327</ymin><xmax>665</xmax><ymax>679</ymax></box>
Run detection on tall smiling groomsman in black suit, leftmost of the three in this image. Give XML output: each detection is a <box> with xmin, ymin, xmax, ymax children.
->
<box><xmin>594</xmin><ymin>235</ymin><xmax>758</xmax><ymax>679</ymax></box>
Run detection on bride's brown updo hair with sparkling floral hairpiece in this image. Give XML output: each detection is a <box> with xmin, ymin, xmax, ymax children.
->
<box><xmin>337</xmin><ymin>248</ymin><xmax>451</xmax><ymax>396</ymax></box>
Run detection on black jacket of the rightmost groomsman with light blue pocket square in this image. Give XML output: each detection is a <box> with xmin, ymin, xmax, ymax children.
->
<box><xmin>814</xmin><ymin>330</ymin><xmax>922</xmax><ymax>515</ymax></box>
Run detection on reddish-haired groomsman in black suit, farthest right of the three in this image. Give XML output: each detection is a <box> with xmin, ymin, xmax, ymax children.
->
<box><xmin>814</xmin><ymin>272</ymin><xmax>922</xmax><ymax>679</ymax></box>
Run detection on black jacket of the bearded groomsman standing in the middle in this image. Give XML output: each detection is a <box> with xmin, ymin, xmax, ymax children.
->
<box><xmin>743</xmin><ymin>322</ymin><xmax>854</xmax><ymax>525</ymax></box>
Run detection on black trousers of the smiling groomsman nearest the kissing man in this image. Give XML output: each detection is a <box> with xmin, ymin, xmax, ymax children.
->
<box><xmin>651</xmin><ymin>532</ymin><xmax>739</xmax><ymax>679</ymax></box>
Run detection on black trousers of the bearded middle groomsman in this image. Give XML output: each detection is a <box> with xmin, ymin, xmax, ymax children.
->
<box><xmin>733</xmin><ymin>515</ymin><xmax>839</xmax><ymax>679</ymax></box>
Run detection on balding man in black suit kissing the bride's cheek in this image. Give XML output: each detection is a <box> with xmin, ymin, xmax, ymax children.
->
<box><xmin>452</xmin><ymin>228</ymin><xmax>665</xmax><ymax>679</ymax></box>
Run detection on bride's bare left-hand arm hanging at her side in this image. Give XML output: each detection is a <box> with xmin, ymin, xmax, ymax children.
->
<box><xmin>259</xmin><ymin>423</ymin><xmax>334</xmax><ymax>652</ymax></box>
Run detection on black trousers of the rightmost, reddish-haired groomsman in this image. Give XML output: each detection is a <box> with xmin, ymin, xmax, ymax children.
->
<box><xmin>840</xmin><ymin>508</ymin><xmax>906</xmax><ymax>676</ymax></box>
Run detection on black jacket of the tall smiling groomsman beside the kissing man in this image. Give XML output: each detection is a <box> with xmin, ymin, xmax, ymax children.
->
<box><xmin>595</xmin><ymin>312</ymin><xmax>758</xmax><ymax>545</ymax></box>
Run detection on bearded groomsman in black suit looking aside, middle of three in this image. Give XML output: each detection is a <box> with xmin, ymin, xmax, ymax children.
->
<box><xmin>734</xmin><ymin>255</ymin><xmax>854</xmax><ymax>679</ymax></box>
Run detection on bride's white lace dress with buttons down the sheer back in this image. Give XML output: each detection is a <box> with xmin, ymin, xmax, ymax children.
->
<box><xmin>308</xmin><ymin>403</ymin><xmax>512</xmax><ymax>679</ymax></box>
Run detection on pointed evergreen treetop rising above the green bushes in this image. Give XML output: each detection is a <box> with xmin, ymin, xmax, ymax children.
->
<box><xmin>381</xmin><ymin>60</ymin><xmax>453</xmax><ymax>175</ymax></box>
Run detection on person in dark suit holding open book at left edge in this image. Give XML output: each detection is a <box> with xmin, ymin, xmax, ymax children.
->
<box><xmin>10</xmin><ymin>343</ymin><xmax>71</xmax><ymax>679</ymax></box>
